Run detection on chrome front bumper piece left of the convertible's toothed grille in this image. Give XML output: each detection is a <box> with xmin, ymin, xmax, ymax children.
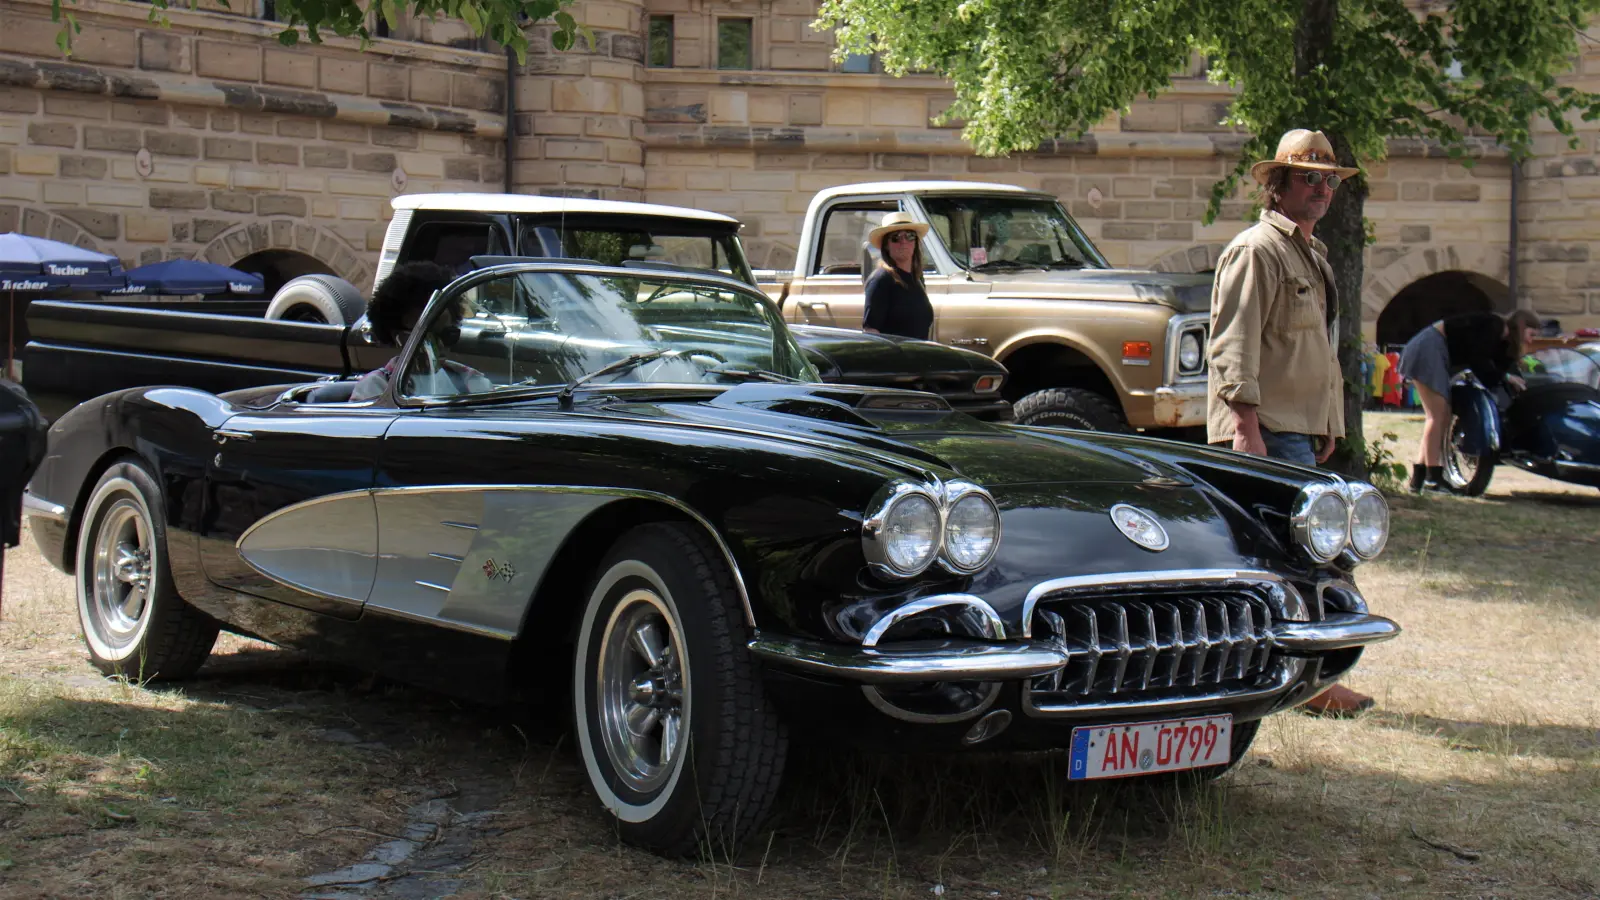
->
<box><xmin>749</xmin><ymin>634</ymin><xmax>1067</xmax><ymax>684</ymax></box>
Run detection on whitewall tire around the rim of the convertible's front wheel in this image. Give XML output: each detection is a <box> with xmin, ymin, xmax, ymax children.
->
<box><xmin>573</xmin><ymin>522</ymin><xmax>787</xmax><ymax>857</ymax></box>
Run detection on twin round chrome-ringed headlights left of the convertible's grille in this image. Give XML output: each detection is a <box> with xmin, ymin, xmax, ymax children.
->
<box><xmin>861</xmin><ymin>482</ymin><xmax>1000</xmax><ymax>578</ymax></box>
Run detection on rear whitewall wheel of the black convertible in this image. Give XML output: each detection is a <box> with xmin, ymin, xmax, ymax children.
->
<box><xmin>75</xmin><ymin>461</ymin><xmax>218</xmax><ymax>682</ymax></box>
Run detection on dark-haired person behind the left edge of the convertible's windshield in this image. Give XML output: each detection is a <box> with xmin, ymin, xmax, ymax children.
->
<box><xmin>350</xmin><ymin>261</ymin><xmax>494</xmax><ymax>400</ymax></box>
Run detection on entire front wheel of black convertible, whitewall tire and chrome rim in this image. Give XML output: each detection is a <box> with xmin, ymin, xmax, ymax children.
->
<box><xmin>573</xmin><ymin>522</ymin><xmax>787</xmax><ymax>855</ymax></box>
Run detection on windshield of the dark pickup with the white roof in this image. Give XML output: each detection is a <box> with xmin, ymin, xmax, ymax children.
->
<box><xmin>518</xmin><ymin>215</ymin><xmax>755</xmax><ymax>285</ymax></box>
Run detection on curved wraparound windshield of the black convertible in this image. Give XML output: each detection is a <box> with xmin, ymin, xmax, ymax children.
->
<box><xmin>400</xmin><ymin>271</ymin><xmax>819</xmax><ymax>397</ymax></box>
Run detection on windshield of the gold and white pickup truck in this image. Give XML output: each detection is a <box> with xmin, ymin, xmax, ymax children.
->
<box><xmin>922</xmin><ymin>194</ymin><xmax>1106</xmax><ymax>272</ymax></box>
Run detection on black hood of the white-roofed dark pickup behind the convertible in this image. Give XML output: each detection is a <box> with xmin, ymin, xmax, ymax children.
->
<box><xmin>789</xmin><ymin>325</ymin><xmax>1005</xmax><ymax>384</ymax></box>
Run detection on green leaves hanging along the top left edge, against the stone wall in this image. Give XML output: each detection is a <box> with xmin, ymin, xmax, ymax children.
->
<box><xmin>50</xmin><ymin>0</ymin><xmax>592</xmax><ymax>62</ymax></box>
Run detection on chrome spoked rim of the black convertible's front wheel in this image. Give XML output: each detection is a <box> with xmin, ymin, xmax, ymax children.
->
<box><xmin>597</xmin><ymin>589</ymin><xmax>688</xmax><ymax>793</ymax></box>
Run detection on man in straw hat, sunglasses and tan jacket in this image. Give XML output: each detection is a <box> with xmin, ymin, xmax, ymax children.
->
<box><xmin>1206</xmin><ymin>128</ymin><xmax>1373</xmax><ymax>716</ymax></box>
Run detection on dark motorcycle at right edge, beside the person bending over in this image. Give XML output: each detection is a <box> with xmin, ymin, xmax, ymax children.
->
<box><xmin>1445</xmin><ymin>348</ymin><xmax>1600</xmax><ymax>496</ymax></box>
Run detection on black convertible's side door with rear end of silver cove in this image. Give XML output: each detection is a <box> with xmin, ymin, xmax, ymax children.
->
<box><xmin>200</xmin><ymin>402</ymin><xmax>397</xmax><ymax>618</ymax></box>
